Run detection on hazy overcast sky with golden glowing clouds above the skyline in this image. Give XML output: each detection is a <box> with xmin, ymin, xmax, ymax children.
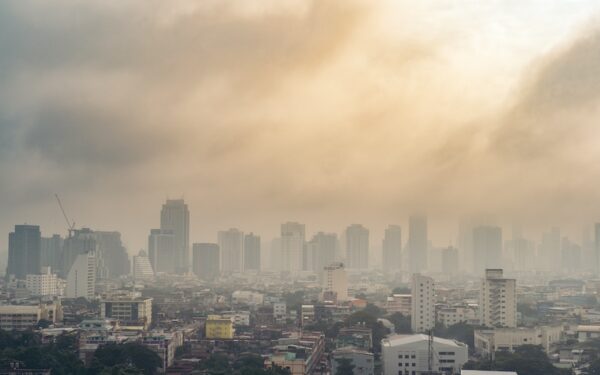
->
<box><xmin>0</xmin><ymin>0</ymin><xmax>600</xmax><ymax>253</ymax></box>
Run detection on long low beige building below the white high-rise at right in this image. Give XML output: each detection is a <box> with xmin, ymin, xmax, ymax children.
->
<box><xmin>474</xmin><ymin>326</ymin><xmax>563</xmax><ymax>358</ymax></box>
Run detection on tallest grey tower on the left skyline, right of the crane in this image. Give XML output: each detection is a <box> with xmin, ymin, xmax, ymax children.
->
<box><xmin>160</xmin><ymin>199</ymin><xmax>190</xmax><ymax>274</ymax></box>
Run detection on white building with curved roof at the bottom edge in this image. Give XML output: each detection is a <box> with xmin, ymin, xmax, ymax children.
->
<box><xmin>381</xmin><ymin>334</ymin><xmax>469</xmax><ymax>375</ymax></box>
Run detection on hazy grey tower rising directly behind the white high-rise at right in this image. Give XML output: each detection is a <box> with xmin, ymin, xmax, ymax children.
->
<box><xmin>473</xmin><ymin>225</ymin><xmax>502</xmax><ymax>274</ymax></box>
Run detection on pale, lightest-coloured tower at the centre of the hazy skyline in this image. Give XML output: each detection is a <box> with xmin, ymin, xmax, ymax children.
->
<box><xmin>280</xmin><ymin>222</ymin><xmax>306</xmax><ymax>272</ymax></box>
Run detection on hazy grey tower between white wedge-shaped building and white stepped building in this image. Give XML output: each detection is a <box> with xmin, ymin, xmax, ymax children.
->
<box><xmin>94</xmin><ymin>231</ymin><xmax>131</xmax><ymax>279</ymax></box>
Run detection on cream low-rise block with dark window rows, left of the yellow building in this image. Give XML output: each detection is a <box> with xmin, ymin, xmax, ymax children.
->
<box><xmin>100</xmin><ymin>297</ymin><xmax>152</xmax><ymax>330</ymax></box>
